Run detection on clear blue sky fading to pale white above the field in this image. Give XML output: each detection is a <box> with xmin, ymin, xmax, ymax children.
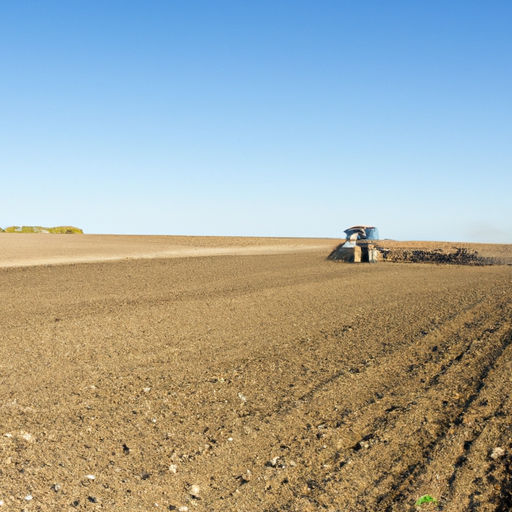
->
<box><xmin>0</xmin><ymin>0</ymin><xmax>512</xmax><ymax>243</ymax></box>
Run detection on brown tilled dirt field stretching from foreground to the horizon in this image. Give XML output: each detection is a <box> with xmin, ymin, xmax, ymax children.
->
<box><xmin>0</xmin><ymin>234</ymin><xmax>512</xmax><ymax>512</ymax></box>
